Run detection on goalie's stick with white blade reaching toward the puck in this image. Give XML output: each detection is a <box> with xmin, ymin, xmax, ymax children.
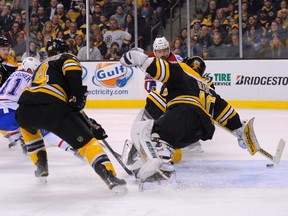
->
<box><xmin>217</xmin><ymin>118</ymin><xmax>285</xmax><ymax>164</ymax></box>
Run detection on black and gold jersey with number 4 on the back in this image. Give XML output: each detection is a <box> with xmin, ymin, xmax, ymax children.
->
<box><xmin>18</xmin><ymin>53</ymin><xmax>83</xmax><ymax>104</ymax></box>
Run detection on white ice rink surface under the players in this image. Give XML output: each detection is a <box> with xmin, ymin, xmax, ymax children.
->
<box><xmin>0</xmin><ymin>109</ymin><xmax>288</xmax><ymax>216</ymax></box>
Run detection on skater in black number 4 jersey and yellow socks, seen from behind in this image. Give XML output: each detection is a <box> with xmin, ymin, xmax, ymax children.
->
<box><xmin>16</xmin><ymin>39</ymin><xmax>126</xmax><ymax>193</ymax></box>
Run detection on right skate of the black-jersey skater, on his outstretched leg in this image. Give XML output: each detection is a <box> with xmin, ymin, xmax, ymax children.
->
<box><xmin>95</xmin><ymin>164</ymin><xmax>128</xmax><ymax>195</ymax></box>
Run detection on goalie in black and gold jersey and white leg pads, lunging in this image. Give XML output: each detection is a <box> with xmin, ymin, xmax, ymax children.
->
<box><xmin>120</xmin><ymin>50</ymin><xmax>260</xmax><ymax>182</ymax></box>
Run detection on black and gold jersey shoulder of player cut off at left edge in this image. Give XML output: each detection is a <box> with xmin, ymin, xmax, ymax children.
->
<box><xmin>0</xmin><ymin>56</ymin><xmax>18</xmax><ymax>87</ymax></box>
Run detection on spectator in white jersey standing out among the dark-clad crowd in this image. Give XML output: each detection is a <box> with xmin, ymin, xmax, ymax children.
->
<box><xmin>103</xmin><ymin>19</ymin><xmax>131</xmax><ymax>50</ymax></box>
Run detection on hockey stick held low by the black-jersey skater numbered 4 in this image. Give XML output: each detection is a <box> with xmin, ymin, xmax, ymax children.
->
<box><xmin>79</xmin><ymin>110</ymin><xmax>134</xmax><ymax>175</ymax></box>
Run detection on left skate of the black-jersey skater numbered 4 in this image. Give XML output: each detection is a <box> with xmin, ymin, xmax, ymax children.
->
<box><xmin>34</xmin><ymin>151</ymin><xmax>49</xmax><ymax>183</ymax></box>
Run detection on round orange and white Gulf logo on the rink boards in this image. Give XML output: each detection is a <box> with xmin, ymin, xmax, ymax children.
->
<box><xmin>92</xmin><ymin>62</ymin><xmax>133</xmax><ymax>88</ymax></box>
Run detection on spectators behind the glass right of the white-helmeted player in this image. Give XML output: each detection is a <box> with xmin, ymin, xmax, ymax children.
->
<box><xmin>171</xmin><ymin>0</ymin><xmax>288</xmax><ymax>59</ymax></box>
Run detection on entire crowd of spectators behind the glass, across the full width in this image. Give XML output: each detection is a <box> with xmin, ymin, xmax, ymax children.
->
<box><xmin>0</xmin><ymin>0</ymin><xmax>288</xmax><ymax>61</ymax></box>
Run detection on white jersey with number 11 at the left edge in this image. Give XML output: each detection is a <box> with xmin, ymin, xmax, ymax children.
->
<box><xmin>0</xmin><ymin>70</ymin><xmax>32</xmax><ymax>110</ymax></box>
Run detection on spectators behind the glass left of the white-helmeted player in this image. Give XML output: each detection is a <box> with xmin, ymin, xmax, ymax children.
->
<box><xmin>0</xmin><ymin>0</ymin><xmax>175</xmax><ymax>61</ymax></box>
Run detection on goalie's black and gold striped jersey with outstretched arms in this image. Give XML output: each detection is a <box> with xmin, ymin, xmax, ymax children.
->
<box><xmin>146</xmin><ymin>58</ymin><xmax>241</xmax><ymax>131</ymax></box>
